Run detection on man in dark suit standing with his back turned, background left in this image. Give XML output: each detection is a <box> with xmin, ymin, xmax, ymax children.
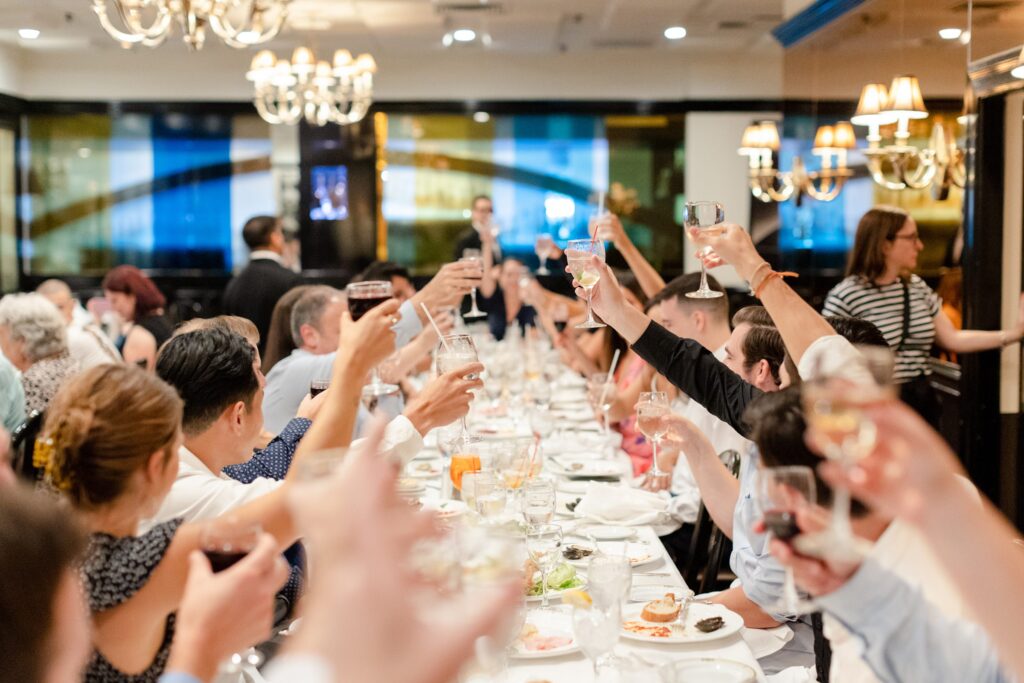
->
<box><xmin>223</xmin><ymin>216</ymin><xmax>302</xmax><ymax>352</ymax></box>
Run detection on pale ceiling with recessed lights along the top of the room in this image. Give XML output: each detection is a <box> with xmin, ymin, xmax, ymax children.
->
<box><xmin>0</xmin><ymin>0</ymin><xmax>782</xmax><ymax>56</ymax></box>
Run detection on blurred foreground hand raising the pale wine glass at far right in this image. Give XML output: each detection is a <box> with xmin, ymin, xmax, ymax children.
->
<box><xmin>808</xmin><ymin>400</ymin><xmax>963</xmax><ymax>522</ymax></box>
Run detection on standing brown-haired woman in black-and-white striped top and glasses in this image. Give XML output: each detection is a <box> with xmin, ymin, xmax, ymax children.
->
<box><xmin>823</xmin><ymin>207</ymin><xmax>1024</xmax><ymax>424</ymax></box>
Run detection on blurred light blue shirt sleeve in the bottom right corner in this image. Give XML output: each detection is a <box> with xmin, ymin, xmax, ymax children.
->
<box><xmin>817</xmin><ymin>560</ymin><xmax>1016</xmax><ymax>683</ymax></box>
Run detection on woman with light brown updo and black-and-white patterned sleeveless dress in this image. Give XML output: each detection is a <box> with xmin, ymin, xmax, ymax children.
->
<box><xmin>37</xmin><ymin>303</ymin><xmax>396</xmax><ymax>683</ymax></box>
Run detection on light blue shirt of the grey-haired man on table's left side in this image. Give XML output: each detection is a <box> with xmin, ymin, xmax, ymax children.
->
<box><xmin>263</xmin><ymin>301</ymin><xmax>423</xmax><ymax>434</ymax></box>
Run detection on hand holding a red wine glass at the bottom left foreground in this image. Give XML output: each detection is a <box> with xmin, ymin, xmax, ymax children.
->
<box><xmin>167</xmin><ymin>533</ymin><xmax>288</xmax><ymax>680</ymax></box>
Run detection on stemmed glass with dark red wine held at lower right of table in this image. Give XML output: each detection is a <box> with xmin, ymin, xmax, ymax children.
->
<box><xmin>757</xmin><ymin>466</ymin><xmax>817</xmax><ymax>615</ymax></box>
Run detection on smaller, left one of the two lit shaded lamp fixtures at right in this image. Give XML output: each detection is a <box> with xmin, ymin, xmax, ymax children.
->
<box><xmin>739</xmin><ymin>121</ymin><xmax>856</xmax><ymax>203</ymax></box>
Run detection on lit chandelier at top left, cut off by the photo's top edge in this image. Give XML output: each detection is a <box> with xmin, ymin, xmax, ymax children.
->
<box><xmin>92</xmin><ymin>0</ymin><xmax>292</xmax><ymax>50</ymax></box>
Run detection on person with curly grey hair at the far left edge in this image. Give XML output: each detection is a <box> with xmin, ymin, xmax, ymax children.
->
<box><xmin>0</xmin><ymin>294</ymin><xmax>79</xmax><ymax>414</ymax></box>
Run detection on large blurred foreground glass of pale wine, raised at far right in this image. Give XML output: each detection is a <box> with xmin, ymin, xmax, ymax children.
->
<box><xmin>801</xmin><ymin>346</ymin><xmax>895</xmax><ymax>560</ymax></box>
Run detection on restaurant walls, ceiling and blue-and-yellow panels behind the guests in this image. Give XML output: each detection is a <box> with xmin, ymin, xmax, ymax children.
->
<box><xmin>0</xmin><ymin>0</ymin><xmax>1024</xmax><ymax>523</ymax></box>
